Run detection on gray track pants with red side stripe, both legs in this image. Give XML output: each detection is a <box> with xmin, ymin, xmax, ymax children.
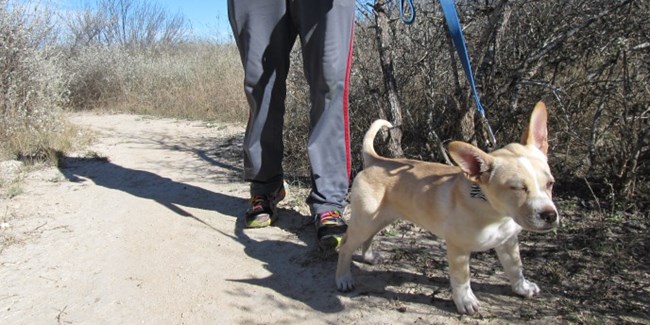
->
<box><xmin>228</xmin><ymin>0</ymin><xmax>355</xmax><ymax>214</ymax></box>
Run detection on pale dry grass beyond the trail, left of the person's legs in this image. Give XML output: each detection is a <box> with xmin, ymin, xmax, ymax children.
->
<box><xmin>67</xmin><ymin>42</ymin><xmax>248</xmax><ymax>122</ymax></box>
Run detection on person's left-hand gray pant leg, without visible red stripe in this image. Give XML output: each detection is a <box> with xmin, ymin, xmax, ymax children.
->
<box><xmin>228</xmin><ymin>0</ymin><xmax>297</xmax><ymax>196</ymax></box>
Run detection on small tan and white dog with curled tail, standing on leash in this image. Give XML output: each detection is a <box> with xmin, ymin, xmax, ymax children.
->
<box><xmin>336</xmin><ymin>102</ymin><xmax>559</xmax><ymax>314</ymax></box>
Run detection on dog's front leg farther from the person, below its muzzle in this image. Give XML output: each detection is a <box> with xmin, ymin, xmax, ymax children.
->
<box><xmin>495</xmin><ymin>235</ymin><xmax>539</xmax><ymax>298</ymax></box>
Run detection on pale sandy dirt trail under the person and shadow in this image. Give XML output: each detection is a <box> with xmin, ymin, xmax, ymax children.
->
<box><xmin>0</xmin><ymin>114</ymin><xmax>540</xmax><ymax>324</ymax></box>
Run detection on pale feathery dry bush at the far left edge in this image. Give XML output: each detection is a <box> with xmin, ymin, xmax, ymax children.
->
<box><xmin>0</xmin><ymin>0</ymin><xmax>69</xmax><ymax>165</ymax></box>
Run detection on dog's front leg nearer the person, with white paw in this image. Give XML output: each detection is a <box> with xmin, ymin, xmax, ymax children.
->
<box><xmin>447</xmin><ymin>243</ymin><xmax>480</xmax><ymax>314</ymax></box>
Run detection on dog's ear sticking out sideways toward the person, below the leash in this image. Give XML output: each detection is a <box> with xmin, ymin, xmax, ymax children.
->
<box><xmin>449</xmin><ymin>141</ymin><xmax>493</xmax><ymax>182</ymax></box>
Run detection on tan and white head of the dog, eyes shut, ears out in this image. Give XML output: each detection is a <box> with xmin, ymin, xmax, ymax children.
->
<box><xmin>449</xmin><ymin>102</ymin><xmax>559</xmax><ymax>232</ymax></box>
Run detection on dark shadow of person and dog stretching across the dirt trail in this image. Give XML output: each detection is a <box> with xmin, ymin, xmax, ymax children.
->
<box><xmin>54</xmin><ymin>151</ymin><xmax>466</xmax><ymax>313</ymax></box>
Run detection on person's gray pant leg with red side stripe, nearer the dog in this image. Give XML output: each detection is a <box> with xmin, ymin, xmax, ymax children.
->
<box><xmin>292</xmin><ymin>0</ymin><xmax>355</xmax><ymax>215</ymax></box>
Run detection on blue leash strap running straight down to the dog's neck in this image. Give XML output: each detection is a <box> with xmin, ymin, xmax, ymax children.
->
<box><xmin>440</xmin><ymin>0</ymin><xmax>497</xmax><ymax>148</ymax></box>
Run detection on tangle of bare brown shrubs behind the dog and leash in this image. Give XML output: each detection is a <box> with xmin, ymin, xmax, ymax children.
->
<box><xmin>285</xmin><ymin>0</ymin><xmax>650</xmax><ymax>211</ymax></box>
